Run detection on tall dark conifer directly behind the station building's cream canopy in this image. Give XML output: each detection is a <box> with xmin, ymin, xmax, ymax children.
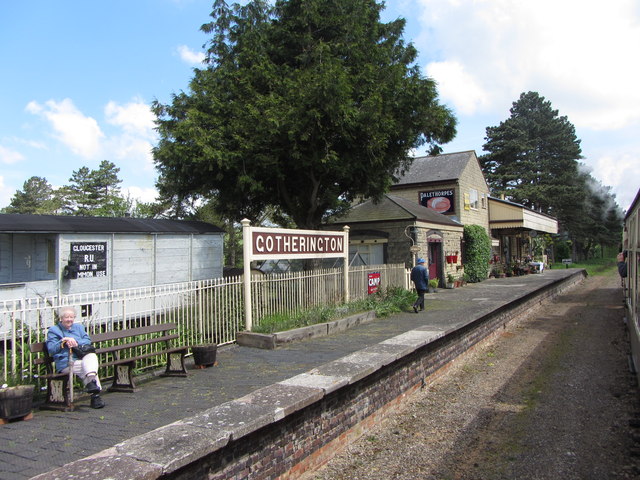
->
<box><xmin>479</xmin><ymin>92</ymin><xmax>583</xmax><ymax>220</ymax></box>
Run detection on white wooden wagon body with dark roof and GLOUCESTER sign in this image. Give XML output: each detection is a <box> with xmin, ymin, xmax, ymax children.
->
<box><xmin>0</xmin><ymin>214</ymin><xmax>224</xmax><ymax>300</ymax></box>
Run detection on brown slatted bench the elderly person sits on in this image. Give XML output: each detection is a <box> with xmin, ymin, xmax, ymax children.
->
<box><xmin>29</xmin><ymin>323</ymin><xmax>188</xmax><ymax>411</ymax></box>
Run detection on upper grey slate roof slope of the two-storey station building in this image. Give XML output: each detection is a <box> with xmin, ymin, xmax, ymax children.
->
<box><xmin>391</xmin><ymin>150</ymin><xmax>475</xmax><ymax>189</ymax></box>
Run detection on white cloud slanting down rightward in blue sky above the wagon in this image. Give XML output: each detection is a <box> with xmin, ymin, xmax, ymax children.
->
<box><xmin>26</xmin><ymin>98</ymin><xmax>104</xmax><ymax>159</ymax></box>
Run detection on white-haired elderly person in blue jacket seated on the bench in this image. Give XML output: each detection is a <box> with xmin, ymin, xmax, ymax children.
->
<box><xmin>47</xmin><ymin>307</ymin><xmax>104</xmax><ymax>408</ymax></box>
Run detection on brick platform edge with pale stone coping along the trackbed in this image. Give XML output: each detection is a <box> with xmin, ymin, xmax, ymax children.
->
<box><xmin>34</xmin><ymin>270</ymin><xmax>586</xmax><ymax>480</ymax></box>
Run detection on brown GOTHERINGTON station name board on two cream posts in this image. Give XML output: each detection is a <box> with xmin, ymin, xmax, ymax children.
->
<box><xmin>242</xmin><ymin>218</ymin><xmax>349</xmax><ymax>331</ymax></box>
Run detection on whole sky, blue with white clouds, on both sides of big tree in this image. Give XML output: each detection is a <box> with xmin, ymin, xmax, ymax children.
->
<box><xmin>0</xmin><ymin>0</ymin><xmax>640</xmax><ymax>214</ymax></box>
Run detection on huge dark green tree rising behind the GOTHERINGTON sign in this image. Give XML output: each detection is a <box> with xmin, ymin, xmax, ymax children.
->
<box><xmin>153</xmin><ymin>0</ymin><xmax>455</xmax><ymax>228</ymax></box>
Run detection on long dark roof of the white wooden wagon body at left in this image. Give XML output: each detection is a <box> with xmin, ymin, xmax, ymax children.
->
<box><xmin>0</xmin><ymin>213</ymin><xmax>223</xmax><ymax>234</ymax></box>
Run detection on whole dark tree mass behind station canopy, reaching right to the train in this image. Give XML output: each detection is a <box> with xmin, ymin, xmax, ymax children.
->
<box><xmin>479</xmin><ymin>92</ymin><xmax>622</xmax><ymax>258</ymax></box>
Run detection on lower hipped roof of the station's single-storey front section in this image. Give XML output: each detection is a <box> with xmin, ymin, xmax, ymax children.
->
<box><xmin>331</xmin><ymin>194</ymin><xmax>462</xmax><ymax>227</ymax></box>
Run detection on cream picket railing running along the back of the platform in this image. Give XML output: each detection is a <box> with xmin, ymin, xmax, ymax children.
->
<box><xmin>0</xmin><ymin>265</ymin><xmax>408</xmax><ymax>381</ymax></box>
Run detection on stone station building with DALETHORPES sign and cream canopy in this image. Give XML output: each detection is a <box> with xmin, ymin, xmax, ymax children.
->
<box><xmin>328</xmin><ymin>150</ymin><xmax>558</xmax><ymax>284</ymax></box>
